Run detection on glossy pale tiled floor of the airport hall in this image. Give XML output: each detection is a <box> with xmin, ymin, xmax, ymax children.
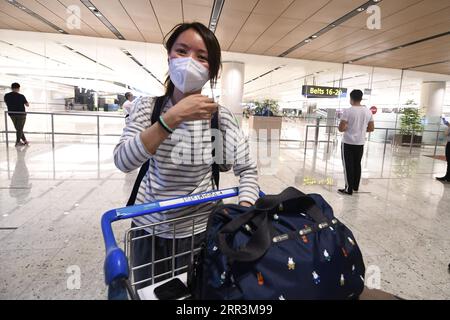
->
<box><xmin>0</xmin><ymin>132</ymin><xmax>450</xmax><ymax>299</ymax></box>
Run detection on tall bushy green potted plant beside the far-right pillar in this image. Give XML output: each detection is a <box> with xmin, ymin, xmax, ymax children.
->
<box><xmin>394</xmin><ymin>100</ymin><xmax>424</xmax><ymax>146</ymax></box>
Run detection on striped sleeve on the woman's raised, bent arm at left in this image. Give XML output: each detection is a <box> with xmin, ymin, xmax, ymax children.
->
<box><xmin>114</xmin><ymin>97</ymin><xmax>154</xmax><ymax>172</ymax></box>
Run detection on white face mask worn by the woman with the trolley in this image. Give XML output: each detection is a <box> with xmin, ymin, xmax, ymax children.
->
<box><xmin>169</xmin><ymin>57</ymin><xmax>209</xmax><ymax>93</ymax></box>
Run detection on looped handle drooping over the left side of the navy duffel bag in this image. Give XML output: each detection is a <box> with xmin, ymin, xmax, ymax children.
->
<box><xmin>217</xmin><ymin>209</ymin><xmax>271</xmax><ymax>262</ymax></box>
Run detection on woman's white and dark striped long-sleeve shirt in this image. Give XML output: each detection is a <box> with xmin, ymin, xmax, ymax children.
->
<box><xmin>114</xmin><ymin>97</ymin><xmax>259</xmax><ymax>238</ymax></box>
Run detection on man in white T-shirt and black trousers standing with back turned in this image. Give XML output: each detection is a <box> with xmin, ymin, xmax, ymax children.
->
<box><xmin>338</xmin><ymin>90</ymin><xmax>375</xmax><ymax>195</ymax></box>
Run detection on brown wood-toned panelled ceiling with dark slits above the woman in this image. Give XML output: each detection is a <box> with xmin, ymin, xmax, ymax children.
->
<box><xmin>0</xmin><ymin>0</ymin><xmax>450</xmax><ymax>74</ymax></box>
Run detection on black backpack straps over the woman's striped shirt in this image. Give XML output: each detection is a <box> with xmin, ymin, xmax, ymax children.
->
<box><xmin>127</xmin><ymin>96</ymin><xmax>221</xmax><ymax>207</ymax></box>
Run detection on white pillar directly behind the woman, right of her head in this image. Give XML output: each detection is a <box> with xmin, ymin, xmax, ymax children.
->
<box><xmin>220</xmin><ymin>61</ymin><xmax>245</xmax><ymax>123</ymax></box>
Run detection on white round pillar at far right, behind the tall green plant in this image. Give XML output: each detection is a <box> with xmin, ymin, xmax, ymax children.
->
<box><xmin>420</xmin><ymin>81</ymin><xmax>446</xmax><ymax>143</ymax></box>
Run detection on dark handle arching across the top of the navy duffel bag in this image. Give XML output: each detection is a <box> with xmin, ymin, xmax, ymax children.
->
<box><xmin>255</xmin><ymin>187</ymin><xmax>328</xmax><ymax>223</ymax></box>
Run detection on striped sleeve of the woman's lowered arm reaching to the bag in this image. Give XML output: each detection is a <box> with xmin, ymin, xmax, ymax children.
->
<box><xmin>220</xmin><ymin>107</ymin><xmax>259</xmax><ymax>204</ymax></box>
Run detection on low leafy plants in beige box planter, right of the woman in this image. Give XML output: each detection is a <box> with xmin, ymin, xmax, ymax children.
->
<box><xmin>249</xmin><ymin>99</ymin><xmax>283</xmax><ymax>140</ymax></box>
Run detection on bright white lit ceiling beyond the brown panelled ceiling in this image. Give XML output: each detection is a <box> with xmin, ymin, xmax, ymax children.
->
<box><xmin>0</xmin><ymin>30</ymin><xmax>450</xmax><ymax>103</ymax></box>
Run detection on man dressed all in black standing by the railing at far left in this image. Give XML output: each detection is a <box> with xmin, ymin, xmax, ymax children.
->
<box><xmin>4</xmin><ymin>83</ymin><xmax>30</xmax><ymax>147</ymax></box>
